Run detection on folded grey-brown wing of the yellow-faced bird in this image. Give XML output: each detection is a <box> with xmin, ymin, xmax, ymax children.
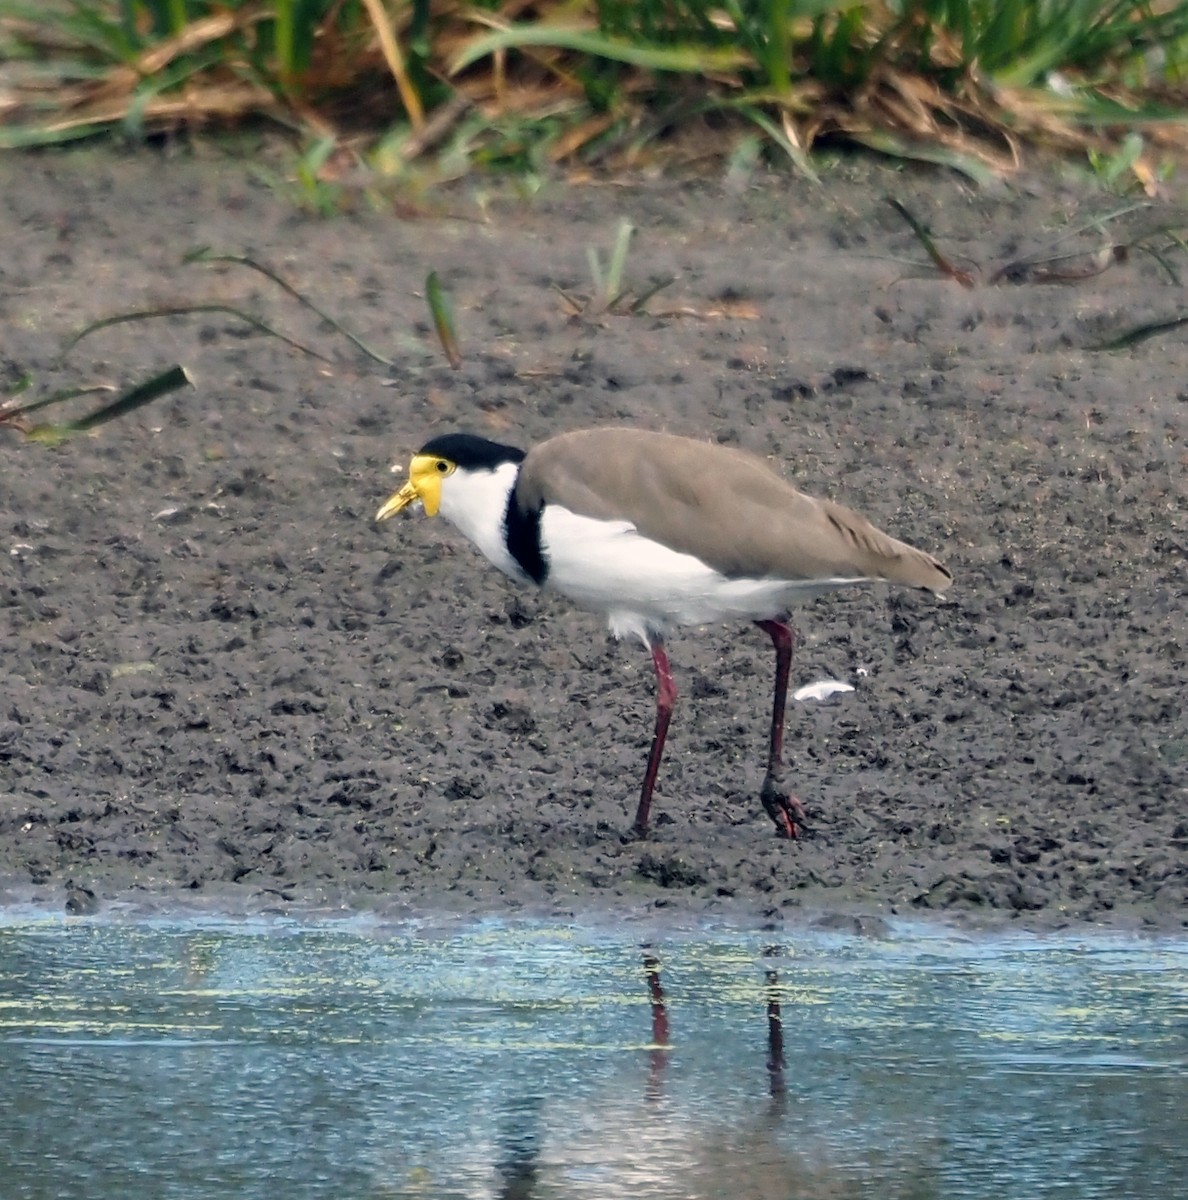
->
<box><xmin>516</xmin><ymin>428</ymin><xmax>953</xmax><ymax>592</ymax></box>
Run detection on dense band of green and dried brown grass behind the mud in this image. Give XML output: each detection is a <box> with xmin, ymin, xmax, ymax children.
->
<box><xmin>0</xmin><ymin>0</ymin><xmax>1188</xmax><ymax>184</ymax></box>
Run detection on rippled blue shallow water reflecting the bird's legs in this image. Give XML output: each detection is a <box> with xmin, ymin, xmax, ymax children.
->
<box><xmin>0</xmin><ymin>913</ymin><xmax>1188</xmax><ymax>1200</ymax></box>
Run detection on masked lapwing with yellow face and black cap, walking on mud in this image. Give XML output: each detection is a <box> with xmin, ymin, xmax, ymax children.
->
<box><xmin>376</xmin><ymin>426</ymin><xmax>953</xmax><ymax>838</ymax></box>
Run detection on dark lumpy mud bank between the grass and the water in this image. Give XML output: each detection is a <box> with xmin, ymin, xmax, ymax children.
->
<box><xmin>0</xmin><ymin>148</ymin><xmax>1188</xmax><ymax>929</ymax></box>
